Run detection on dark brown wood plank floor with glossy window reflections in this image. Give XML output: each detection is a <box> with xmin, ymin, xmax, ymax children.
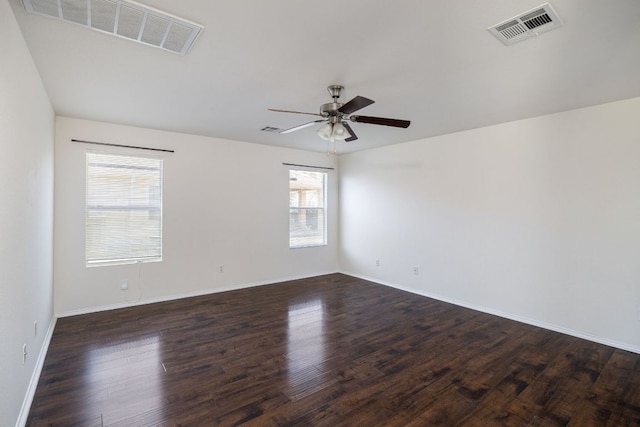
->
<box><xmin>28</xmin><ymin>274</ymin><xmax>640</xmax><ymax>427</ymax></box>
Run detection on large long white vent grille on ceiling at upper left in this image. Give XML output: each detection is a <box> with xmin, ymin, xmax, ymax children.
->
<box><xmin>23</xmin><ymin>0</ymin><xmax>202</xmax><ymax>55</ymax></box>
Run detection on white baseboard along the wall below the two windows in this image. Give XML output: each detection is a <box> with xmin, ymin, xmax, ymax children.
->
<box><xmin>56</xmin><ymin>271</ymin><xmax>338</xmax><ymax>318</ymax></box>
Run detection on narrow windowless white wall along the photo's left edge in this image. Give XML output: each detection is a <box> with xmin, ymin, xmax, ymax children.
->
<box><xmin>0</xmin><ymin>1</ymin><xmax>54</xmax><ymax>426</ymax></box>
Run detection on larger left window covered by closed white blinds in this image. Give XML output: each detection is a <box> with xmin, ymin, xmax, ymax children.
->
<box><xmin>85</xmin><ymin>152</ymin><xmax>162</xmax><ymax>266</ymax></box>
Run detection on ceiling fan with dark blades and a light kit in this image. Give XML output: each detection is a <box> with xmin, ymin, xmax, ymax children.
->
<box><xmin>269</xmin><ymin>85</ymin><xmax>411</xmax><ymax>149</ymax></box>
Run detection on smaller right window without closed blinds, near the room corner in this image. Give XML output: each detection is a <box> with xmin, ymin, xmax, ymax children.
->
<box><xmin>289</xmin><ymin>169</ymin><xmax>327</xmax><ymax>248</ymax></box>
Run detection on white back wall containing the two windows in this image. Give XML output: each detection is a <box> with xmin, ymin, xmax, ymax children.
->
<box><xmin>54</xmin><ymin>117</ymin><xmax>338</xmax><ymax>315</ymax></box>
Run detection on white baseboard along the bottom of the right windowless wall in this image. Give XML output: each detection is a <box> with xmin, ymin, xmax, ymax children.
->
<box><xmin>341</xmin><ymin>271</ymin><xmax>640</xmax><ymax>354</ymax></box>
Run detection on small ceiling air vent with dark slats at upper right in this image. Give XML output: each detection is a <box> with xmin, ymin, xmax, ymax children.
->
<box><xmin>489</xmin><ymin>3</ymin><xmax>562</xmax><ymax>46</ymax></box>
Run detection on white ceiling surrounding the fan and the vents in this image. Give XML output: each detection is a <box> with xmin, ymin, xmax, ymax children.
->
<box><xmin>3</xmin><ymin>0</ymin><xmax>640</xmax><ymax>153</ymax></box>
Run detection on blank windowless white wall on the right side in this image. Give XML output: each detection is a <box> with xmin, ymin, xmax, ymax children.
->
<box><xmin>340</xmin><ymin>98</ymin><xmax>640</xmax><ymax>352</ymax></box>
